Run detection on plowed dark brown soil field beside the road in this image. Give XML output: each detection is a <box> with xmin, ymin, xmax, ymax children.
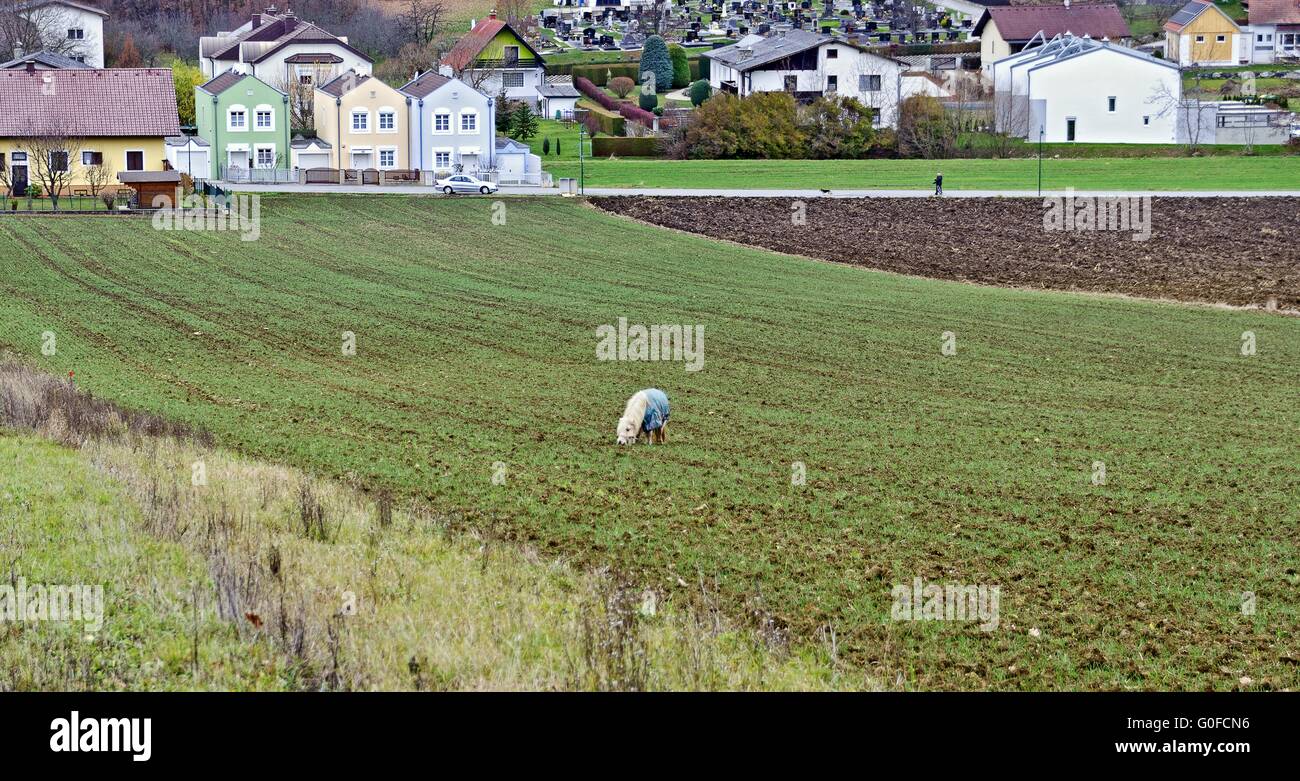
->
<box><xmin>593</xmin><ymin>196</ymin><xmax>1300</xmax><ymax>309</ymax></box>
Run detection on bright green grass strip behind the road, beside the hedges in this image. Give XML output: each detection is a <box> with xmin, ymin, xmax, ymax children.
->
<box><xmin>545</xmin><ymin>156</ymin><xmax>1300</xmax><ymax>191</ymax></box>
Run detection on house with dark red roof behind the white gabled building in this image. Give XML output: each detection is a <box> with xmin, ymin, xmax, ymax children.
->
<box><xmin>971</xmin><ymin>0</ymin><xmax>1132</xmax><ymax>66</ymax></box>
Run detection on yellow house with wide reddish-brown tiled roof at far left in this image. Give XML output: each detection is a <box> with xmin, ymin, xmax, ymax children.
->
<box><xmin>0</xmin><ymin>68</ymin><xmax>181</xmax><ymax>192</ymax></box>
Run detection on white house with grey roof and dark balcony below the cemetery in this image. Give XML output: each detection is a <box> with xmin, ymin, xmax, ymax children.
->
<box><xmin>703</xmin><ymin>30</ymin><xmax>907</xmax><ymax>127</ymax></box>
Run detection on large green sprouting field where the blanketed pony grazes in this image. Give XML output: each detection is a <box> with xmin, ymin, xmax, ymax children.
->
<box><xmin>0</xmin><ymin>196</ymin><xmax>1300</xmax><ymax>689</ymax></box>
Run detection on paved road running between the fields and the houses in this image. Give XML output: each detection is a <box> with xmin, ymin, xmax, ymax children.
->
<box><xmin>228</xmin><ymin>185</ymin><xmax>1300</xmax><ymax>199</ymax></box>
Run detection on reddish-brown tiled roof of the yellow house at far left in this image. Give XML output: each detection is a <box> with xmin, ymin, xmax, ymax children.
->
<box><xmin>0</xmin><ymin>68</ymin><xmax>181</xmax><ymax>138</ymax></box>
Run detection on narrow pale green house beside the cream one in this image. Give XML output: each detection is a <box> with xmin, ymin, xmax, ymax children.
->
<box><xmin>194</xmin><ymin>70</ymin><xmax>290</xmax><ymax>179</ymax></box>
